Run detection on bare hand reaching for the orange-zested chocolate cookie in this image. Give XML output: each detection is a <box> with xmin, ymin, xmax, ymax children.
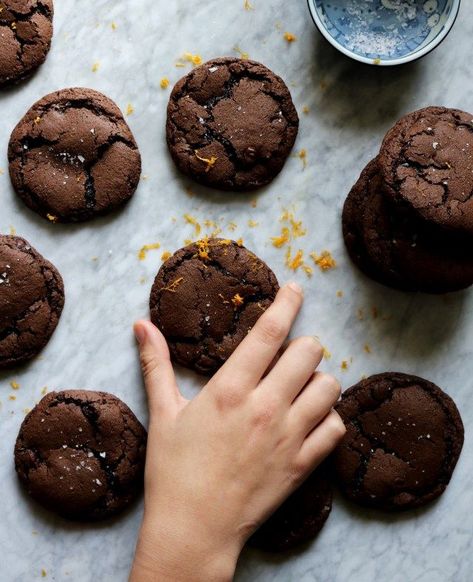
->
<box><xmin>131</xmin><ymin>284</ymin><xmax>345</xmax><ymax>582</ymax></box>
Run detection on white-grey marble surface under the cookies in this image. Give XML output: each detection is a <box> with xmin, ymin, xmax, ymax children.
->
<box><xmin>0</xmin><ymin>0</ymin><xmax>473</xmax><ymax>582</ymax></box>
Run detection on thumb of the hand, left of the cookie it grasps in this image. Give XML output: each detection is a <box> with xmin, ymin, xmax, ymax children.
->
<box><xmin>133</xmin><ymin>321</ymin><xmax>183</xmax><ymax>416</ymax></box>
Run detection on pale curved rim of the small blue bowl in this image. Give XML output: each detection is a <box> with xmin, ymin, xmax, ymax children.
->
<box><xmin>307</xmin><ymin>0</ymin><xmax>461</xmax><ymax>67</ymax></box>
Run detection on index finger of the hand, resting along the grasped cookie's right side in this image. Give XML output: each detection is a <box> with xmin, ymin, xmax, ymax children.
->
<box><xmin>212</xmin><ymin>283</ymin><xmax>303</xmax><ymax>390</ymax></box>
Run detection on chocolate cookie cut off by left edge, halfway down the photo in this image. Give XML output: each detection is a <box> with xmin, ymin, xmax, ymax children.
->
<box><xmin>0</xmin><ymin>235</ymin><xmax>64</xmax><ymax>368</ymax></box>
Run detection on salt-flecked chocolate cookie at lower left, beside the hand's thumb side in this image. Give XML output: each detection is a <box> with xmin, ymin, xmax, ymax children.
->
<box><xmin>15</xmin><ymin>390</ymin><xmax>146</xmax><ymax>521</ymax></box>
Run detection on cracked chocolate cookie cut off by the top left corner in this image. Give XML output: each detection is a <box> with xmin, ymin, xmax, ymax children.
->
<box><xmin>0</xmin><ymin>0</ymin><xmax>53</xmax><ymax>87</ymax></box>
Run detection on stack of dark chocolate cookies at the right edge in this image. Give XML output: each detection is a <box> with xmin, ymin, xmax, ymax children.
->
<box><xmin>343</xmin><ymin>107</ymin><xmax>473</xmax><ymax>293</ymax></box>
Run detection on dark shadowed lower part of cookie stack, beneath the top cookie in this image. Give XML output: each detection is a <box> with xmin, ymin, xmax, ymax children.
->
<box><xmin>343</xmin><ymin>159</ymin><xmax>473</xmax><ymax>293</ymax></box>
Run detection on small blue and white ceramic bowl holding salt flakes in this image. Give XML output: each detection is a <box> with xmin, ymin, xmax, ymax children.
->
<box><xmin>308</xmin><ymin>0</ymin><xmax>461</xmax><ymax>66</ymax></box>
